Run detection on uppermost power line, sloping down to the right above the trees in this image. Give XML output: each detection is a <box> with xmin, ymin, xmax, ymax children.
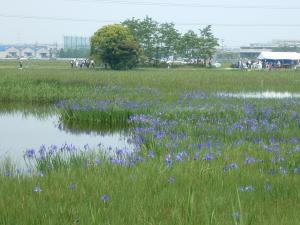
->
<box><xmin>66</xmin><ymin>0</ymin><xmax>300</xmax><ymax>10</ymax></box>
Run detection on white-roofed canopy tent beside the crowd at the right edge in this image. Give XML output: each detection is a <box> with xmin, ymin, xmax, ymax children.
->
<box><xmin>257</xmin><ymin>52</ymin><xmax>300</xmax><ymax>68</ymax></box>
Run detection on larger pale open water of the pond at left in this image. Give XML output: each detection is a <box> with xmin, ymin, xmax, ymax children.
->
<box><xmin>0</xmin><ymin>112</ymin><xmax>133</xmax><ymax>162</ymax></box>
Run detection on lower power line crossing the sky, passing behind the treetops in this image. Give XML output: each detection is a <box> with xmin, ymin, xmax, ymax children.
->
<box><xmin>0</xmin><ymin>14</ymin><xmax>300</xmax><ymax>28</ymax></box>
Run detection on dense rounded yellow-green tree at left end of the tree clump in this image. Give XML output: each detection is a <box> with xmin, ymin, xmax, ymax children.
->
<box><xmin>91</xmin><ymin>24</ymin><xmax>140</xmax><ymax>70</ymax></box>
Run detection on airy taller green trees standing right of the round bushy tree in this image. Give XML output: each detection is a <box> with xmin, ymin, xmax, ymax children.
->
<box><xmin>122</xmin><ymin>16</ymin><xmax>218</xmax><ymax>64</ymax></box>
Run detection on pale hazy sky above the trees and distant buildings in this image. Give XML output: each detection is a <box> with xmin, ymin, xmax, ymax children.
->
<box><xmin>0</xmin><ymin>0</ymin><xmax>300</xmax><ymax>46</ymax></box>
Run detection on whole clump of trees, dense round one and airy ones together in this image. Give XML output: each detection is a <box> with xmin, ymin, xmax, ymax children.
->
<box><xmin>91</xmin><ymin>16</ymin><xmax>218</xmax><ymax>69</ymax></box>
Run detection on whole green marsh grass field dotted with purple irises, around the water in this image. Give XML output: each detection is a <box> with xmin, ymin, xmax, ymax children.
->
<box><xmin>0</xmin><ymin>61</ymin><xmax>300</xmax><ymax>225</ymax></box>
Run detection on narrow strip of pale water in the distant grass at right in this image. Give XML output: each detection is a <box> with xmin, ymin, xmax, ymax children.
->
<box><xmin>216</xmin><ymin>91</ymin><xmax>300</xmax><ymax>99</ymax></box>
